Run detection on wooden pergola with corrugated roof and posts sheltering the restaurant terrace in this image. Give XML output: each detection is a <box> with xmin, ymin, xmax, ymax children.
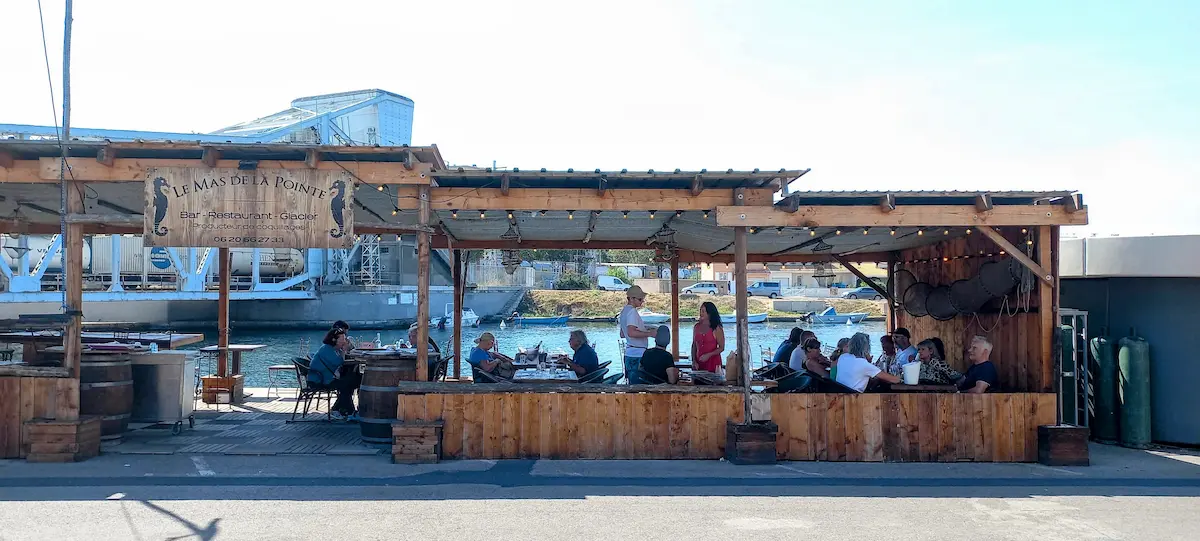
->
<box><xmin>0</xmin><ymin>142</ymin><xmax>1087</xmax><ymax>459</ymax></box>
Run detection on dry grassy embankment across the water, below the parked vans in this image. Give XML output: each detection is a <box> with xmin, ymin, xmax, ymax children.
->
<box><xmin>517</xmin><ymin>289</ymin><xmax>883</xmax><ymax>318</ymax></box>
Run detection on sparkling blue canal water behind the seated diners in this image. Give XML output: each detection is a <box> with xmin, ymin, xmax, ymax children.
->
<box><xmin>181</xmin><ymin>321</ymin><xmax>887</xmax><ymax>387</ymax></box>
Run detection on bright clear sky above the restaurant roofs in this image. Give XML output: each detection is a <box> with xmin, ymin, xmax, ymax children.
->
<box><xmin>0</xmin><ymin>0</ymin><xmax>1200</xmax><ymax>235</ymax></box>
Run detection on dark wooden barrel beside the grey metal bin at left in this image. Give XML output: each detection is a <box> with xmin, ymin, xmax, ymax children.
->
<box><xmin>79</xmin><ymin>351</ymin><xmax>133</xmax><ymax>440</ymax></box>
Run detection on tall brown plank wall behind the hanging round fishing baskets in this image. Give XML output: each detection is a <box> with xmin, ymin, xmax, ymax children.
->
<box><xmin>896</xmin><ymin>228</ymin><xmax>1054</xmax><ymax>392</ymax></box>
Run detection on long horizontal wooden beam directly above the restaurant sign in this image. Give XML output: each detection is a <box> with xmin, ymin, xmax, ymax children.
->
<box><xmin>28</xmin><ymin>158</ymin><xmax>431</xmax><ymax>186</ymax></box>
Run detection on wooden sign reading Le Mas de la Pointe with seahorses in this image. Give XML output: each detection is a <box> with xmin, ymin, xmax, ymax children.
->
<box><xmin>144</xmin><ymin>167</ymin><xmax>354</xmax><ymax>248</ymax></box>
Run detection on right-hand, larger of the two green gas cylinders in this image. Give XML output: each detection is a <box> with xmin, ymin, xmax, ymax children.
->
<box><xmin>1117</xmin><ymin>333</ymin><xmax>1150</xmax><ymax>449</ymax></box>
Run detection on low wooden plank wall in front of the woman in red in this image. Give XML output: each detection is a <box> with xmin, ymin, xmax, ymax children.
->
<box><xmin>396</xmin><ymin>392</ymin><xmax>742</xmax><ymax>458</ymax></box>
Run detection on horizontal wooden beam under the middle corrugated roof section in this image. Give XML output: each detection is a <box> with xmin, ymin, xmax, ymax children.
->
<box><xmin>397</xmin><ymin>188</ymin><xmax>774</xmax><ymax>212</ymax></box>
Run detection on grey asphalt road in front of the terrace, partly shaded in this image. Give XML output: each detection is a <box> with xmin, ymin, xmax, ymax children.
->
<box><xmin>0</xmin><ymin>446</ymin><xmax>1200</xmax><ymax>541</ymax></box>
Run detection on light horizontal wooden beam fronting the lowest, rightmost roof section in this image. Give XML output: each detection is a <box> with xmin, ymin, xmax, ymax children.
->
<box><xmin>716</xmin><ymin>205</ymin><xmax>1087</xmax><ymax>227</ymax></box>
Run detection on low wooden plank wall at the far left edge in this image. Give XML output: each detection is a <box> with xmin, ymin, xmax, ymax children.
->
<box><xmin>0</xmin><ymin>377</ymin><xmax>79</xmax><ymax>458</ymax></box>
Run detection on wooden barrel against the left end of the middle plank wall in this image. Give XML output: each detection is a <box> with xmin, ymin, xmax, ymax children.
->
<box><xmin>359</xmin><ymin>359</ymin><xmax>416</xmax><ymax>444</ymax></box>
